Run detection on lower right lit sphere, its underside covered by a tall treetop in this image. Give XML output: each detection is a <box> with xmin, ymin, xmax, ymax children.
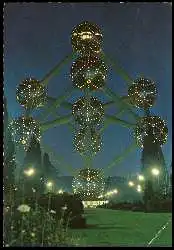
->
<box><xmin>135</xmin><ymin>116</ymin><xmax>168</xmax><ymax>147</ymax></box>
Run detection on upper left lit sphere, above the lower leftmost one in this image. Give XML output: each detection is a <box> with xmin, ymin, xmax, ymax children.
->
<box><xmin>16</xmin><ymin>78</ymin><xmax>46</xmax><ymax>109</ymax></box>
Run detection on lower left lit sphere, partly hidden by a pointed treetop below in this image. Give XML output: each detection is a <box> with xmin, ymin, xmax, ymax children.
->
<box><xmin>9</xmin><ymin>116</ymin><xmax>41</xmax><ymax>151</ymax></box>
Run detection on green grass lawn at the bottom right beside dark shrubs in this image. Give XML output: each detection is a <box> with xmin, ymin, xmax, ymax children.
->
<box><xmin>70</xmin><ymin>208</ymin><xmax>172</xmax><ymax>246</ymax></box>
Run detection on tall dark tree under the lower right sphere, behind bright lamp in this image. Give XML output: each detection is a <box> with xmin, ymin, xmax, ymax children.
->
<box><xmin>142</xmin><ymin>126</ymin><xmax>166</xmax><ymax>210</ymax></box>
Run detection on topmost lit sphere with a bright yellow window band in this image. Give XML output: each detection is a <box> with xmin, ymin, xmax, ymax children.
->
<box><xmin>71</xmin><ymin>21</ymin><xmax>102</xmax><ymax>55</ymax></box>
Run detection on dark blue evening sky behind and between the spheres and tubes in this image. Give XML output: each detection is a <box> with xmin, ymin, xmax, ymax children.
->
<box><xmin>4</xmin><ymin>3</ymin><xmax>172</xmax><ymax>175</ymax></box>
